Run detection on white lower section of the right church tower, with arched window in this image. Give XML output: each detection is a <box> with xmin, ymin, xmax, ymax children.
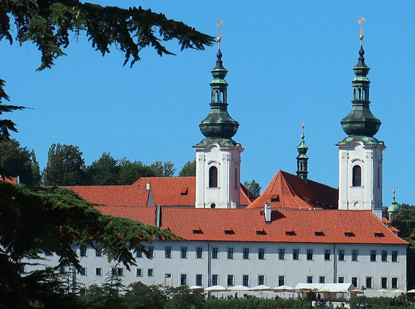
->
<box><xmin>338</xmin><ymin>140</ymin><xmax>385</xmax><ymax>219</ymax></box>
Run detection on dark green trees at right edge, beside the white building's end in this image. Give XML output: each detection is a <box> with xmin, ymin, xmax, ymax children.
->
<box><xmin>392</xmin><ymin>204</ymin><xmax>415</xmax><ymax>290</ymax></box>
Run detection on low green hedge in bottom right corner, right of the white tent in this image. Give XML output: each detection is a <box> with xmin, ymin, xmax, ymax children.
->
<box><xmin>350</xmin><ymin>296</ymin><xmax>412</xmax><ymax>309</ymax></box>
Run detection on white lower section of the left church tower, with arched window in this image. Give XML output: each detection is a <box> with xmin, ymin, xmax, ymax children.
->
<box><xmin>194</xmin><ymin>141</ymin><xmax>243</xmax><ymax>208</ymax></box>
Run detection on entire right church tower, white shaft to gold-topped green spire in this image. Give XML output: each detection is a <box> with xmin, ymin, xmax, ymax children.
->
<box><xmin>337</xmin><ymin>18</ymin><xmax>386</xmax><ymax>219</ymax></box>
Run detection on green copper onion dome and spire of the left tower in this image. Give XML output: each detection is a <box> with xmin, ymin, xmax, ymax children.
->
<box><xmin>199</xmin><ymin>49</ymin><xmax>239</xmax><ymax>139</ymax></box>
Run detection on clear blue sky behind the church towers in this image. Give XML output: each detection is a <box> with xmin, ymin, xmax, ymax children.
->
<box><xmin>0</xmin><ymin>0</ymin><xmax>415</xmax><ymax>205</ymax></box>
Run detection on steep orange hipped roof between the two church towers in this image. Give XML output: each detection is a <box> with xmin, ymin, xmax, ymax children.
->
<box><xmin>248</xmin><ymin>171</ymin><xmax>338</xmax><ymax>209</ymax></box>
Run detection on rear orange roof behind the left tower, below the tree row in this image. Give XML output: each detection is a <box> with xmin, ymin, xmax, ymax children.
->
<box><xmin>66</xmin><ymin>177</ymin><xmax>251</xmax><ymax>207</ymax></box>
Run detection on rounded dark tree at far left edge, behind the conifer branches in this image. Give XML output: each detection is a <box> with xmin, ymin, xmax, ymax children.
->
<box><xmin>0</xmin><ymin>139</ymin><xmax>40</xmax><ymax>186</ymax></box>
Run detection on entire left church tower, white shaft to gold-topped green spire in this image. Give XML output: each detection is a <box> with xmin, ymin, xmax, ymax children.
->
<box><xmin>193</xmin><ymin>24</ymin><xmax>243</xmax><ymax>208</ymax></box>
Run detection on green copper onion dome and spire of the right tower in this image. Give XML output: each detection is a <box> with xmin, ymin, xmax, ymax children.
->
<box><xmin>340</xmin><ymin>46</ymin><xmax>381</xmax><ymax>137</ymax></box>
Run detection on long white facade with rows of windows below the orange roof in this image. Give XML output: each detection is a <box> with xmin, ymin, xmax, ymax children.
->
<box><xmin>35</xmin><ymin>241</ymin><xmax>406</xmax><ymax>296</ymax></box>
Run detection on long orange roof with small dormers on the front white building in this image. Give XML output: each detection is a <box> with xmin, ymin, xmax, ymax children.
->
<box><xmin>93</xmin><ymin>206</ymin><xmax>407</xmax><ymax>245</ymax></box>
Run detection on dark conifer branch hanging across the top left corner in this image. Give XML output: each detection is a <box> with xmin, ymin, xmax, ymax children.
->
<box><xmin>0</xmin><ymin>0</ymin><xmax>213</xmax><ymax>70</ymax></box>
